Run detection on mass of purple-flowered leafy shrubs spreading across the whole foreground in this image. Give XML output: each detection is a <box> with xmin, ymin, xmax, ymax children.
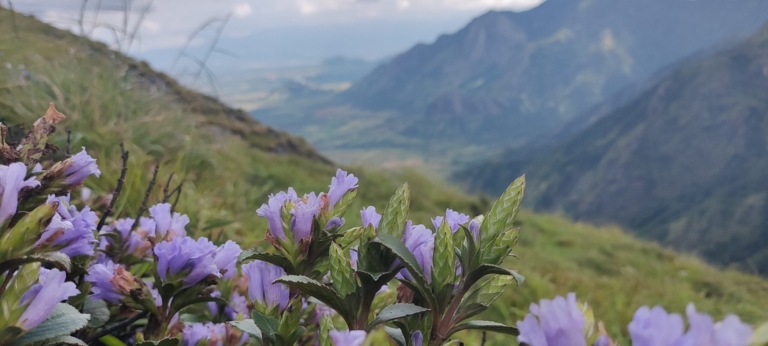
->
<box><xmin>0</xmin><ymin>106</ymin><xmax>753</xmax><ymax>346</ymax></box>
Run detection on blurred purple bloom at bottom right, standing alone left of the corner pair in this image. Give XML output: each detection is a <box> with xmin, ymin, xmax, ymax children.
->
<box><xmin>517</xmin><ymin>293</ymin><xmax>587</xmax><ymax>346</ymax></box>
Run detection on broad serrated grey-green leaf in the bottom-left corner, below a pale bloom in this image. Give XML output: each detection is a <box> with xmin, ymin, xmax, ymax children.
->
<box><xmin>11</xmin><ymin>303</ymin><xmax>91</xmax><ymax>346</ymax></box>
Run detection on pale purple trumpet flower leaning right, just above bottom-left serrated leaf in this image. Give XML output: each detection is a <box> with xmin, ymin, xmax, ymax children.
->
<box><xmin>16</xmin><ymin>269</ymin><xmax>80</xmax><ymax>330</ymax></box>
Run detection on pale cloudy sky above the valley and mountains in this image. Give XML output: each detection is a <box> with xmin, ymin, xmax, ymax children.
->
<box><xmin>13</xmin><ymin>0</ymin><xmax>543</xmax><ymax>68</ymax></box>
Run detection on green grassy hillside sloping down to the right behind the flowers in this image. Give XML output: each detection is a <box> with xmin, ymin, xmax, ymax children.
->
<box><xmin>0</xmin><ymin>11</ymin><xmax>768</xmax><ymax>345</ymax></box>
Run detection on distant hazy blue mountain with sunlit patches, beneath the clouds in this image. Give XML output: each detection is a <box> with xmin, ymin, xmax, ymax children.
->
<box><xmin>253</xmin><ymin>0</ymin><xmax>768</xmax><ymax>166</ymax></box>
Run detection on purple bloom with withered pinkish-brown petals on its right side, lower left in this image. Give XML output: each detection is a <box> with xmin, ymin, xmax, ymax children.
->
<box><xmin>85</xmin><ymin>261</ymin><xmax>136</xmax><ymax>304</ymax></box>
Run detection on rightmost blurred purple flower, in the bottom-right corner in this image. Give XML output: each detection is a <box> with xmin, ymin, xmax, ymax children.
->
<box><xmin>674</xmin><ymin>303</ymin><xmax>752</xmax><ymax>346</ymax></box>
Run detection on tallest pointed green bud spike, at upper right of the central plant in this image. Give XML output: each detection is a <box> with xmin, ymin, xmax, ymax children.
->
<box><xmin>480</xmin><ymin>176</ymin><xmax>525</xmax><ymax>250</ymax></box>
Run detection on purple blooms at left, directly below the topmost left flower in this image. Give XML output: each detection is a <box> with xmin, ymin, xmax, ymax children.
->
<box><xmin>35</xmin><ymin>196</ymin><xmax>98</xmax><ymax>257</ymax></box>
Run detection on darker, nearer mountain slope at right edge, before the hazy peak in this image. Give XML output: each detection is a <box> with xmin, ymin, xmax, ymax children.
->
<box><xmin>464</xmin><ymin>24</ymin><xmax>768</xmax><ymax>274</ymax></box>
